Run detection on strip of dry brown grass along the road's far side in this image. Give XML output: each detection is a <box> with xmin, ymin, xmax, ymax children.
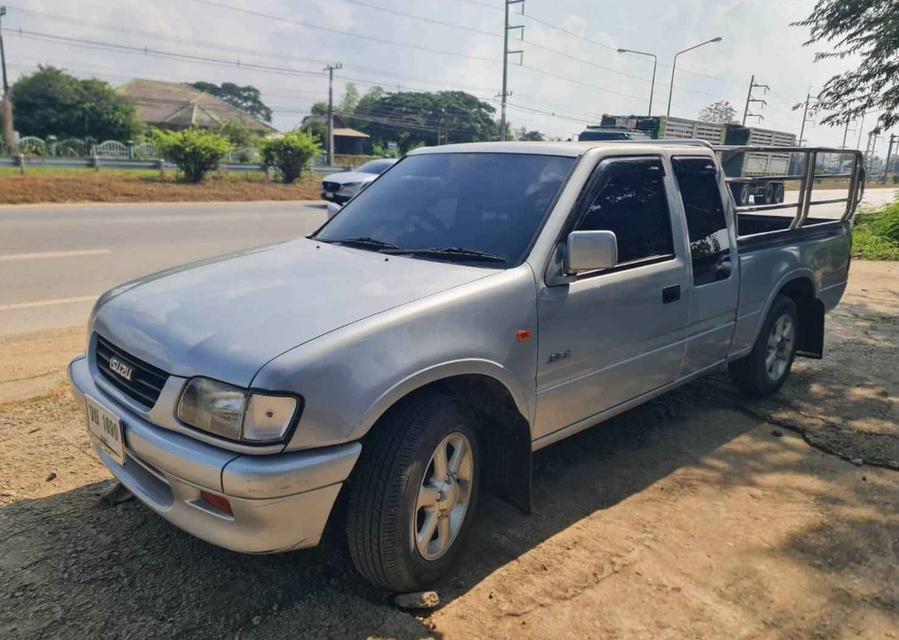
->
<box><xmin>0</xmin><ymin>170</ymin><xmax>321</xmax><ymax>204</ymax></box>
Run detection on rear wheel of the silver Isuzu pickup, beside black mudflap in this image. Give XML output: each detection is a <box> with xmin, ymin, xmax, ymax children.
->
<box><xmin>728</xmin><ymin>295</ymin><xmax>799</xmax><ymax>398</ymax></box>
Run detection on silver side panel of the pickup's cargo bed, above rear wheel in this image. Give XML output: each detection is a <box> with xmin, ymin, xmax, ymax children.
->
<box><xmin>730</xmin><ymin>222</ymin><xmax>852</xmax><ymax>358</ymax></box>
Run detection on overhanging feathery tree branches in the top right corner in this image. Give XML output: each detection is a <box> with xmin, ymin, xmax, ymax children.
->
<box><xmin>793</xmin><ymin>0</ymin><xmax>899</xmax><ymax>129</ymax></box>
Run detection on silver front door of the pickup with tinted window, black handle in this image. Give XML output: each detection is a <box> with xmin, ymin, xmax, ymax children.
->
<box><xmin>534</xmin><ymin>157</ymin><xmax>690</xmax><ymax>438</ymax></box>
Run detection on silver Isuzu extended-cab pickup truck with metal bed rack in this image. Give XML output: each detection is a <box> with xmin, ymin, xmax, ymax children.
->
<box><xmin>69</xmin><ymin>141</ymin><xmax>863</xmax><ymax>591</ymax></box>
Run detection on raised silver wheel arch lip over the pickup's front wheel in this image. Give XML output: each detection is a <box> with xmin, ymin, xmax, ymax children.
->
<box><xmin>354</xmin><ymin>358</ymin><xmax>534</xmax><ymax>438</ymax></box>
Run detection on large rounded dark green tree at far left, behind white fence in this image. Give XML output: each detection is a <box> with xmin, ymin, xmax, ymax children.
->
<box><xmin>12</xmin><ymin>66</ymin><xmax>141</xmax><ymax>140</ymax></box>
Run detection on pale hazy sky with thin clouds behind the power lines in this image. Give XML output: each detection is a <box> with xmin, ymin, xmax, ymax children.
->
<box><xmin>0</xmin><ymin>0</ymin><xmax>886</xmax><ymax>155</ymax></box>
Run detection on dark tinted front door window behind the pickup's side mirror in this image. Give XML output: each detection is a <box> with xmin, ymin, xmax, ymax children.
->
<box><xmin>577</xmin><ymin>159</ymin><xmax>674</xmax><ymax>263</ymax></box>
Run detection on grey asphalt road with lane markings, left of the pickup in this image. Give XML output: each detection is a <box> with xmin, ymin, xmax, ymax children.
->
<box><xmin>0</xmin><ymin>202</ymin><xmax>326</xmax><ymax>335</ymax></box>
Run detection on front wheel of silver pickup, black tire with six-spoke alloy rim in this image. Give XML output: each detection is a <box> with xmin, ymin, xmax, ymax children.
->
<box><xmin>346</xmin><ymin>393</ymin><xmax>480</xmax><ymax>592</ymax></box>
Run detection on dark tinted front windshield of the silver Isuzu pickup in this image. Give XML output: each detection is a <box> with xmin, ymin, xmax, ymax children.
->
<box><xmin>315</xmin><ymin>153</ymin><xmax>575</xmax><ymax>267</ymax></box>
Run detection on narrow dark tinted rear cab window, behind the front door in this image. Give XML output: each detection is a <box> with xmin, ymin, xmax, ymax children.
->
<box><xmin>672</xmin><ymin>158</ymin><xmax>730</xmax><ymax>286</ymax></box>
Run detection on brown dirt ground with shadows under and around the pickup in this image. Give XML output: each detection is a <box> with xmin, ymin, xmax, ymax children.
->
<box><xmin>0</xmin><ymin>261</ymin><xmax>899</xmax><ymax>639</ymax></box>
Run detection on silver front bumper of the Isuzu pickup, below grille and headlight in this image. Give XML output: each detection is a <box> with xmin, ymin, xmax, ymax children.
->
<box><xmin>69</xmin><ymin>356</ymin><xmax>362</xmax><ymax>553</ymax></box>
